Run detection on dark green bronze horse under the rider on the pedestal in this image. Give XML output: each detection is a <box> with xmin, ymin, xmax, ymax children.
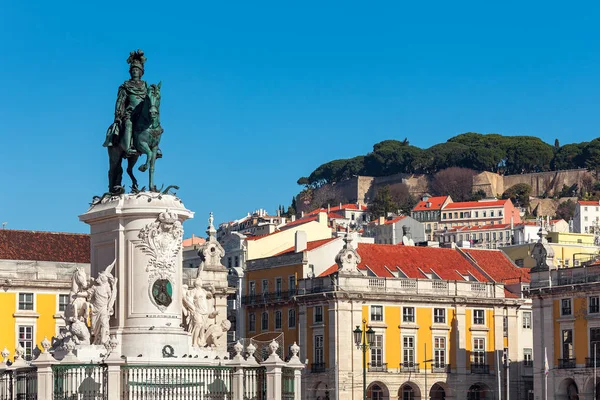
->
<box><xmin>107</xmin><ymin>83</ymin><xmax>163</xmax><ymax>194</ymax></box>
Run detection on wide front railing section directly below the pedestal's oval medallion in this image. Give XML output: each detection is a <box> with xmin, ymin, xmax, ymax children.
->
<box><xmin>121</xmin><ymin>365</ymin><xmax>233</xmax><ymax>400</ymax></box>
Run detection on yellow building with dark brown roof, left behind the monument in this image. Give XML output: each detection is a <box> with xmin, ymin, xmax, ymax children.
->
<box><xmin>0</xmin><ymin>229</ymin><xmax>90</xmax><ymax>358</ymax></box>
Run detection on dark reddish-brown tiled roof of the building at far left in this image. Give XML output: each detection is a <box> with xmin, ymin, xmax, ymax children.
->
<box><xmin>0</xmin><ymin>229</ymin><xmax>90</xmax><ymax>263</ymax></box>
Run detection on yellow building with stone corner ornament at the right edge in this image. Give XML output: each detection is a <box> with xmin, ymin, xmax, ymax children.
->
<box><xmin>530</xmin><ymin>231</ymin><xmax>600</xmax><ymax>400</ymax></box>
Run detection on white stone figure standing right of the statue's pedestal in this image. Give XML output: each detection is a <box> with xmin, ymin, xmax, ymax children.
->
<box><xmin>183</xmin><ymin>278</ymin><xmax>219</xmax><ymax>347</ymax></box>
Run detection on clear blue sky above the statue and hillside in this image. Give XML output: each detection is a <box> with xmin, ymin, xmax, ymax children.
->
<box><xmin>0</xmin><ymin>0</ymin><xmax>600</xmax><ymax>236</ymax></box>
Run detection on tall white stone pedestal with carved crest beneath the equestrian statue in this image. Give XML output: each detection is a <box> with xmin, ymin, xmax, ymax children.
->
<box><xmin>79</xmin><ymin>192</ymin><xmax>193</xmax><ymax>359</ymax></box>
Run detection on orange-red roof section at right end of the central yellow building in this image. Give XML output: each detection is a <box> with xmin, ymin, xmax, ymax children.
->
<box><xmin>462</xmin><ymin>249</ymin><xmax>530</xmax><ymax>283</ymax></box>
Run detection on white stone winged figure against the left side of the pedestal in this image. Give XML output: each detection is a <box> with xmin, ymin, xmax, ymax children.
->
<box><xmin>88</xmin><ymin>260</ymin><xmax>117</xmax><ymax>345</ymax></box>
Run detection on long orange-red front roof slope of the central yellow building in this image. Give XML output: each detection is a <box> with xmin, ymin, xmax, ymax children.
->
<box><xmin>357</xmin><ymin>243</ymin><xmax>489</xmax><ymax>282</ymax></box>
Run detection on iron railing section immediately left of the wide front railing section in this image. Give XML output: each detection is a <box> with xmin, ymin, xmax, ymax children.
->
<box><xmin>53</xmin><ymin>364</ymin><xmax>108</xmax><ymax>400</ymax></box>
